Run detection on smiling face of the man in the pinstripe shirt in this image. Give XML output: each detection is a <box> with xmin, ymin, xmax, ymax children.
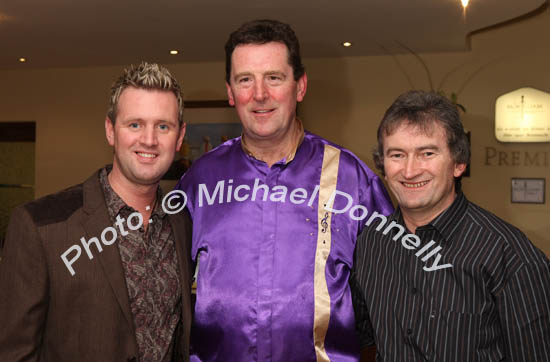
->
<box><xmin>384</xmin><ymin>121</ymin><xmax>466</xmax><ymax>218</ymax></box>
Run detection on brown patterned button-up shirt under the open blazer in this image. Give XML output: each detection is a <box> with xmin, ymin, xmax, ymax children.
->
<box><xmin>100</xmin><ymin>166</ymin><xmax>181</xmax><ymax>362</ymax></box>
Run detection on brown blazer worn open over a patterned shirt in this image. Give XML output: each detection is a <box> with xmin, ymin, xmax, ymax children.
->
<box><xmin>0</xmin><ymin>172</ymin><xmax>192</xmax><ymax>362</ymax></box>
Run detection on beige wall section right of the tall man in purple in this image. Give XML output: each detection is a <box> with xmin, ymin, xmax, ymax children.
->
<box><xmin>300</xmin><ymin>11</ymin><xmax>550</xmax><ymax>255</ymax></box>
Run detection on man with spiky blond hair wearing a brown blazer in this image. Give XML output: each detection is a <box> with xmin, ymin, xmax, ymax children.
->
<box><xmin>0</xmin><ymin>63</ymin><xmax>191</xmax><ymax>362</ymax></box>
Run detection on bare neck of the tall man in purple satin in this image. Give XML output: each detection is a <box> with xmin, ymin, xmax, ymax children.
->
<box><xmin>245</xmin><ymin>119</ymin><xmax>300</xmax><ymax>167</ymax></box>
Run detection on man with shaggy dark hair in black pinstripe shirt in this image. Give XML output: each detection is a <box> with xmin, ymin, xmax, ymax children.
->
<box><xmin>350</xmin><ymin>91</ymin><xmax>550</xmax><ymax>362</ymax></box>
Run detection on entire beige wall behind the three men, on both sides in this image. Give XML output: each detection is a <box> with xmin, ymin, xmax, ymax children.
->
<box><xmin>0</xmin><ymin>11</ymin><xmax>550</xmax><ymax>255</ymax></box>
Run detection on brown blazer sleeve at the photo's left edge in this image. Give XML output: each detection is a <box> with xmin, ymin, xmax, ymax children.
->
<box><xmin>0</xmin><ymin>207</ymin><xmax>49</xmax><ymax>362</ymax></box>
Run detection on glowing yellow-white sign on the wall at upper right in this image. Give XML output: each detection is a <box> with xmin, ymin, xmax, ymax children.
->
<box><xmin>495</xmin><ymin>87</ymin><xmax>550</xmax><ymax>142</ymax></box>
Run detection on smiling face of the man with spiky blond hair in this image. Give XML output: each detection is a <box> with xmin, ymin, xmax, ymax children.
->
<box><xmin>105</xmin><ymin>87</ymin><xmax>185</xmax><ymax>185</ymax></box>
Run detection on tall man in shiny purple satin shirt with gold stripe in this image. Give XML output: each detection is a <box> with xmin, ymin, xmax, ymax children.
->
<box><xmin>177</xmin><ymin>20</ymin><xmax>393</xmax><ymax>362</ymax></box>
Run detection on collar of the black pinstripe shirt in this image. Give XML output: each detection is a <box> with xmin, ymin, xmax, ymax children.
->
<box><xmin>394</xmin><ymin>191</ymin><xmax>468</xmax><ymax>240</ymax></box>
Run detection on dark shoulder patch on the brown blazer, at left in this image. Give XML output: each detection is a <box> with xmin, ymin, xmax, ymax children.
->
<box><xmin>21</xmin><ymin>184</ymin><xmax>84</xmax><ymax>226</ymax></box>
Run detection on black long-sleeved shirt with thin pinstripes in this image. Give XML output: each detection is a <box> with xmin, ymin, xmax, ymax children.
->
<box><xmin>350</xmin><ymin>193</ymin><xmax>550</xmax><ymax>362</ymax></box>
